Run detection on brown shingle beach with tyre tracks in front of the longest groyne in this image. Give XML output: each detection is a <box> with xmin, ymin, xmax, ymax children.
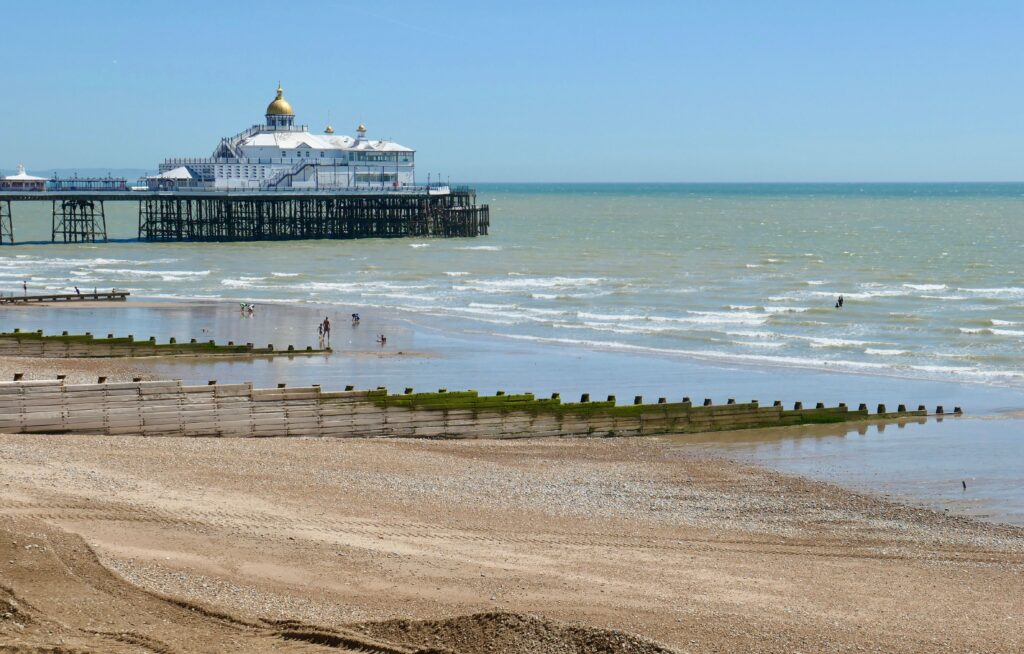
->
<box><xmin>0</xmin><ymin>429</ymin><xmax>1024</xmax><ymax>652</ymax></box>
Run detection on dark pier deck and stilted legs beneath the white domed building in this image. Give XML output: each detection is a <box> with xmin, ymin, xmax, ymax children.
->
<box><xmin>0</xmin><ymin>186</ymin><xmax>490</xmax><ymax>245</ymax></box>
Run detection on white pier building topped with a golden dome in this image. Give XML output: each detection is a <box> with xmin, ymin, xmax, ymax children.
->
<box><xmin>146</xmin><ymin>84</ymin><xmax>416</xmax><ymax>192</ymax></box>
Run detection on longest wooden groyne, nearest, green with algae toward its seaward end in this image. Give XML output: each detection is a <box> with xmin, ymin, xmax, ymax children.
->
<box><xmin>0</xmin><ymin>381</ymin><xmax>959</xmax><ymax>439</ymax></box>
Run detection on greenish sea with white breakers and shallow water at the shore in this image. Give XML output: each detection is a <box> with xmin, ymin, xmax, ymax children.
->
<box><xmin>0</xmin><ymin>183</ymin><xmax>1024</xmax><ymax>524</ymax></box>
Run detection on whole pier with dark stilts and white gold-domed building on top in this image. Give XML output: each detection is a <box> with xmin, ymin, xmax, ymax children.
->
<box><xmin>0</xmin><ymin>83</ymin><xmax>489</xmax><ymax>243</ymax></box>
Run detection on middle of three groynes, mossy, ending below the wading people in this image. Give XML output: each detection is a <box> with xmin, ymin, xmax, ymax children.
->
<box><xmin>0</xmin><ymin>330</ymin><xmax>331</xmax><ymax>358</ymax></box>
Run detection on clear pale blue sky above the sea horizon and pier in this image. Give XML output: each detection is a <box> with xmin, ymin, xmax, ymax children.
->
<box><xmin>0</xmin><ymin>0</ymin><xmax>1024</xmax><ymax>181</ymax></box>
